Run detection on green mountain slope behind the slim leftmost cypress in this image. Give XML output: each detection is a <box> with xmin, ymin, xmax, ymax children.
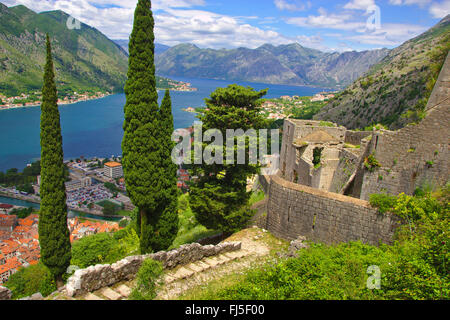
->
<box><xmin>0</xmin><ymin>3</ymin><xmax>178</xmax><ymax>96</ymax></box>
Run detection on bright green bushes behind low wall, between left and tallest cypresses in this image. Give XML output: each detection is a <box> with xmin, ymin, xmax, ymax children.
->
<box><xmin>71</xmin><ymin>226</ymin><xmax>139</xmax><ymax>268</ymax></box>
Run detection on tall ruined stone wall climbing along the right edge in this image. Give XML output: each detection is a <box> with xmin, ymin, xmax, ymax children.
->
<box><xmin>361</xmin><ymin>55</ymin><xmax>450</xmax><ymax>199</ymax></box>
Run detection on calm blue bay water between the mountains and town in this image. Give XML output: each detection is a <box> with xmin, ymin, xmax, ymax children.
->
<box><xmin>0</xmin><ymin>77</ymin><xmax>325</xmax><ymax>171</ymax></box>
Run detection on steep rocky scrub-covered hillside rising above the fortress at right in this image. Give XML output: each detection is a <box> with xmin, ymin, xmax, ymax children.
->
<box><xmin>315</xmin><ymin>15</ymin><xmax>450</xmax><ymax>129</ymax></box>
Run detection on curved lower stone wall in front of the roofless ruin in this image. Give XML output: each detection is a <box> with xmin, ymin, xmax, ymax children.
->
<box><xmin>267</xmin><ymin>176</ymin><xmax>400</xmax><ymax>245</ymax></box>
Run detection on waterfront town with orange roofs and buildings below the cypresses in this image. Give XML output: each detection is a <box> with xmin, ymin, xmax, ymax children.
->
<box><xmin>0</xmin><ymin>157</ymin><xmax>191</xmax><ymax>284</ymax></box>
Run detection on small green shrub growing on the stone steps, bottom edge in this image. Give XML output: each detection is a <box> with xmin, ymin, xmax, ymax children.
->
<box><xmin>128</xmin><ymin>259</ymin><xmax>163</xmax><ymax>300</ymax></box>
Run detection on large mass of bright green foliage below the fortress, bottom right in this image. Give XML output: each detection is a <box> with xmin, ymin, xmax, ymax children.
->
<box><xmin>192</xmin><ymin>187</ymin><xmax>450</xmax><ymax>300</ymax></box>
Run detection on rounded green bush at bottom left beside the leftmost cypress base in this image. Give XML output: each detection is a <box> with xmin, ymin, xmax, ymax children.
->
<box><xmin>5</xmin><ymin>263</ymin><xmax>57</xmax><ymax>299</ymax></box>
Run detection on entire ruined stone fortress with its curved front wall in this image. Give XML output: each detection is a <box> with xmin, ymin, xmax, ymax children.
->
<box><xmin>259</xmin><ymin>55</ymin><xmax>450</xmax><ymax>245</ymax></box>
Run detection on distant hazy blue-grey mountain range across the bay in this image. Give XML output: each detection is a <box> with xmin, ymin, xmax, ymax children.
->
<box><xmin>155</xmin><ymin>43</ymin><xmax>389</xmax><ymax>88</ymax></box>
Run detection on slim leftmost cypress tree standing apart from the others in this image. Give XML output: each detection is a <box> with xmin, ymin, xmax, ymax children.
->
<box><xmin>39</xmin><ymin>34</ymin><xmax>71</xmax><ymax>285</ymax></box>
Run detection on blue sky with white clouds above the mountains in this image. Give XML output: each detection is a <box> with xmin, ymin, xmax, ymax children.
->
<box><xmin>0</xmin><ymin>0</ymin><xmax>450</xmax><ymax>51</ymax></box>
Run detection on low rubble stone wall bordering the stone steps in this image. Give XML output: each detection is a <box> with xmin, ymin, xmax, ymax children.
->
<box><xmin>66</xmin><ymin>242</ymin><xmax>241</xmax><ymax>297</ymax></box>
